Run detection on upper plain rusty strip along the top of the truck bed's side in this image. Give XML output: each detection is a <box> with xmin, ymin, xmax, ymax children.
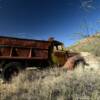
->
<box><xmin>0</xmin><ymin>37</ymin><xmax>50</xmax><ymax>49</ymax></box>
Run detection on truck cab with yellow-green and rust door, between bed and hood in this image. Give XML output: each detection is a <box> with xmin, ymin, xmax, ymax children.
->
<box><xmin>48</xmin><ymin>40</ymin><xmax>67</xmax><ymax>66</ymax></box>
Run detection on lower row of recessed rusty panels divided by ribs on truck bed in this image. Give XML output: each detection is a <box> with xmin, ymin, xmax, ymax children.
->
<box><xmin>0</xmin><ymin>48</ymin><xmax>48</xmax><ymax>58</ymax></box>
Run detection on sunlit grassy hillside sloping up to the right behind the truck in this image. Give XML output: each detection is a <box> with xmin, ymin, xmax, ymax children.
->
<box><xmin>67</xmin><ymin>33</ymin><xmax>100</xmax><ymax>56</ymax></box>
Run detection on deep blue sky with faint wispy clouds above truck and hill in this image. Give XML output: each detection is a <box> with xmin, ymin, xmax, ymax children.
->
<box><xmin>0</xmin><ymin>0</ymin><xmax>100</xmax><ymax>46</ymax></box>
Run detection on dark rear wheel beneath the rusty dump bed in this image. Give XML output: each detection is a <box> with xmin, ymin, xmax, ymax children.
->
<box><xmin>3</xmin><ymin>62</ymin><xmax>20</xmax><ymax>81</ymax></box>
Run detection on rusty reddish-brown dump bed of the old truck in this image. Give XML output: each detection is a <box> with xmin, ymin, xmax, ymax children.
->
<box><xmin>0</xmin><ymin>36</ymin><xmax>51</xmax><ymax>59</ymax></box>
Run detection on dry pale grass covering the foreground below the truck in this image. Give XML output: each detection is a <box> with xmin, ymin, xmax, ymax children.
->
<box><xmin>0</xmin><ymin>68</ymin><xmax>100</xmax><ymax>100</ymax></box>
